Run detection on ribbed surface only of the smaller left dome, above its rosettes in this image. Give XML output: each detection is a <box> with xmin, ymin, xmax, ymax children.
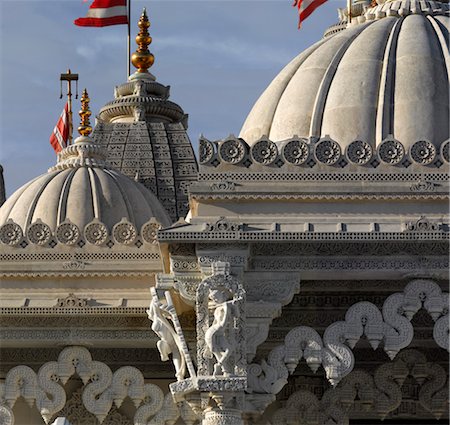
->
<box><xmin>0</xmin><ymin>167</ymin><xmax>170</xmax><ymax>231</ymax></box>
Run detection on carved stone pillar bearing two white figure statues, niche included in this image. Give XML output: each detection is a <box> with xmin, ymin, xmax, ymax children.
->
<box><xmin>149</xmin><ymin>262</ymin><xmax>247</xmax><ymax>425</ymax></box>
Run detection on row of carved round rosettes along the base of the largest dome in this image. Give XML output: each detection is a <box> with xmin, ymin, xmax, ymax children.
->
<box><xmin>199</xmin><ymin>135</ymin><xmax>448</xmax><ymax>172</ymax></box>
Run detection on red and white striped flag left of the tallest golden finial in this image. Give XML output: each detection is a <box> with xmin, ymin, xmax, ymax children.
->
<box><xmin>73</xmin><ymin>0</ymin><xmax>128</xmax><ymax>27</ymax></box>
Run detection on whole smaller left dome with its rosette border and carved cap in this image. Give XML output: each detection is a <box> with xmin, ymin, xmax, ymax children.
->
<box><xmin>0</xmin><ymin>137</ymin><xmax>171</xmax><ymax>246</ymax></box>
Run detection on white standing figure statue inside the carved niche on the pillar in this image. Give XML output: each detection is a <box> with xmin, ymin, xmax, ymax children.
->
<box><xmin>205</xmin><ymin>287</ymin><xmax>239</xmax><ymax>376</ymax></box>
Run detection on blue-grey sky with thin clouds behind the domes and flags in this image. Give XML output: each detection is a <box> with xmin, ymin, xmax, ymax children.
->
<box><xmin>0</xmin><ymin>0</ymin><xmax>338</xmax><ymax>196</ymax></box>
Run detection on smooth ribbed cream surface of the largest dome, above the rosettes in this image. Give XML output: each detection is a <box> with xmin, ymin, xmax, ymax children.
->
<box><xmin>240</xmin><ymin>9</ymin><xmax>450</xmax><ymax>152</ymax></box>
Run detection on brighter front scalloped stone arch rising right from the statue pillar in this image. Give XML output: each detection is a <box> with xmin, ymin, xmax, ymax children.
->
<box><xmin>248</xmin><ymin>279</ymin><xmax>449</xmax><ymax>394</ymax></box>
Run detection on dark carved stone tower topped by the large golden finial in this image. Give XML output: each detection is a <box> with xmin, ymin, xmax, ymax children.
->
<box><xmin>93</xmin><ymin>10</ymin><xmax>197</xmax><ymax>221</ymax></box>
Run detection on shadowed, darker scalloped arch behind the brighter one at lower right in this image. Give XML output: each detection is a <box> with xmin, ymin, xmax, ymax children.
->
<box><xmin>271</xmin><ymin>350</ymin><xmax>448</xmax><ymax>425</ymax></box>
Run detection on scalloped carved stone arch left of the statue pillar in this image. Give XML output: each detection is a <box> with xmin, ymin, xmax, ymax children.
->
<box><xmin>0</xmin><ymin>346</ymin><xmax>164</xmax><ymax>425</ymax></box>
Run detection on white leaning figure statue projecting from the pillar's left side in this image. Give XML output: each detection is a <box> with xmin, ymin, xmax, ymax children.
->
<box><xmin>147</xmin><ymin>288</ymin><xmax>186</xmax><ymax>381</ymax></box>
